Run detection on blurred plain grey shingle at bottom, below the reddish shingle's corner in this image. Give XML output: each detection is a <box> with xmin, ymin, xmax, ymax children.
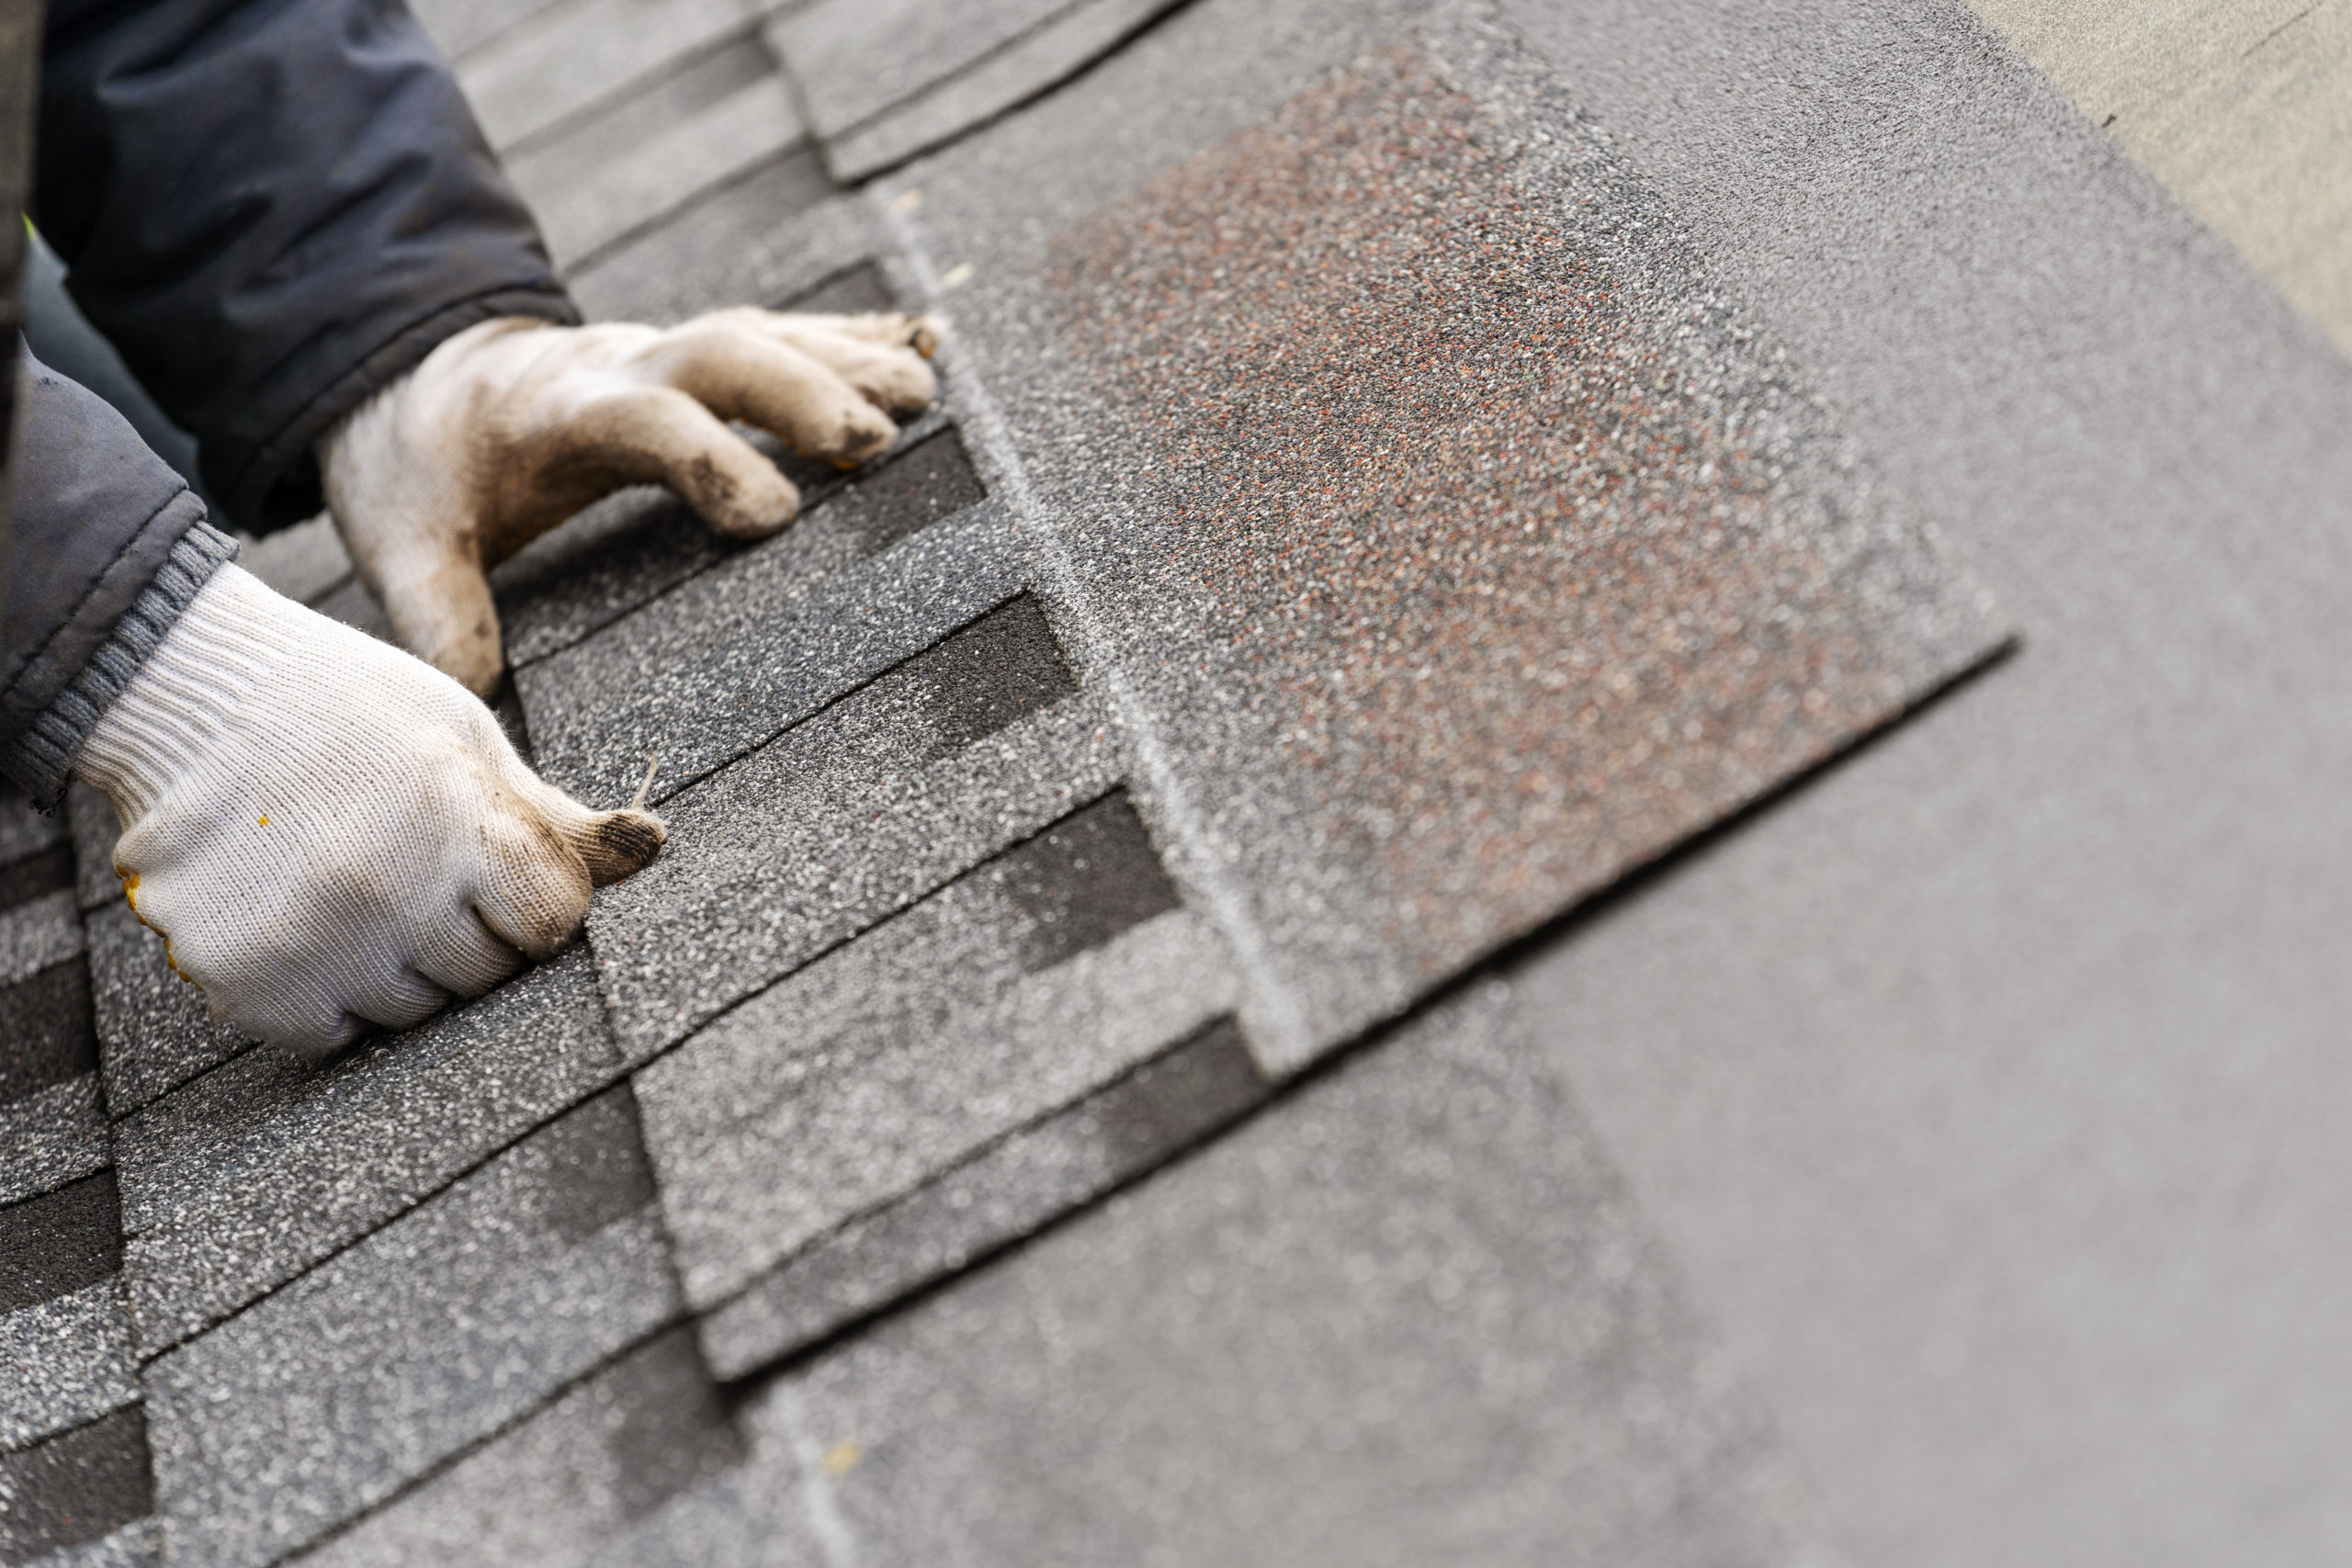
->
<box><xmin>762</xmin><ymin>983</ymin><xmax>1835</xmax><ymax>1565</ymax></box>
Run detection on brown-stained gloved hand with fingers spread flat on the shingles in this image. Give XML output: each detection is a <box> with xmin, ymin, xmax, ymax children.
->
<box><xmin>318</xmin><ymin>308</ymin><xmax>938</xmax><ymax>696</ymax></box>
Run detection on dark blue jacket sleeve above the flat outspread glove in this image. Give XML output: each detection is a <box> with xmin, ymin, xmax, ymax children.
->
<box><xmin>33</xmin><ymin>0</ymin><xmax>579</xmax><ymax>529</ymax></box>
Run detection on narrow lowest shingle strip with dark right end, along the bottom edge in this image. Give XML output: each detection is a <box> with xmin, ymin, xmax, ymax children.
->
<box><xmin>695</xmin><ymin>1018</ymin><xmax>1272</xmax><ymax>1378</ymax></box>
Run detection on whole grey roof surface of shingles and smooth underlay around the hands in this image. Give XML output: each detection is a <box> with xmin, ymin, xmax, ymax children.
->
<box><xmin>0</xmin><ymin>0</ymin><xmax>2352</xmax><ymax>1568</ymax></box>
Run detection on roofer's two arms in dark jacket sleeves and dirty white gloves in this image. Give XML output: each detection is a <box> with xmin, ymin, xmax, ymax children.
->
<box><xmin>0</xmin><ymin>0</ymin><xmax>932</xmax><ymax>1051</ymax></box>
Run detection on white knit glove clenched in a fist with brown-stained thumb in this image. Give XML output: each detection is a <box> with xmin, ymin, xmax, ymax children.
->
<box><xmin>75</xmin><ymin>567</ymin><xmax>661</xmax><ymax>1055</ymax></box>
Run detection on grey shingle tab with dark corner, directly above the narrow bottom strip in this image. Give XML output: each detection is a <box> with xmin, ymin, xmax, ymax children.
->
<box><xmin>638</xmin><ymin>795</ymin><xmax>1235</xmax><ymax>1307</ymax></box>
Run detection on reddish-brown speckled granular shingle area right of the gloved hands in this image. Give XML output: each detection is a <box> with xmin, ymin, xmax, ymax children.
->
<box><xmin>1025</xmin><ymin>26</ymin><xmax>1999</xmax><ymax>1063</ymax></box>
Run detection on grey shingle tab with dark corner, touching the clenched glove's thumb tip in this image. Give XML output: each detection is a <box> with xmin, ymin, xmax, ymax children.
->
<box><xmin>588</xmin><ymin>600</ymin><xmax>1122</xmax><ymax>1060</ymax></box>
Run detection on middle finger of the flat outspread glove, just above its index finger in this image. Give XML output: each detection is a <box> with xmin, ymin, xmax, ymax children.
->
<box><xmin>642</xmin><ymin>317</ymin><xmax>899</xmax><ymax>468</ymax></box>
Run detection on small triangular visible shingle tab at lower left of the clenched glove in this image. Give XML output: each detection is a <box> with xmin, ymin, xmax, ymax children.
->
<box><xmin>87</xmin><ymin>898</ymin><xmax>256</xmax><ymax>1117</ymax></box>
